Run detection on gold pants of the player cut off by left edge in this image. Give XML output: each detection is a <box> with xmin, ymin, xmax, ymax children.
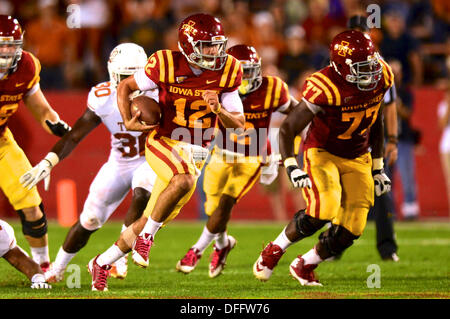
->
<box><xmin>0</xmin><ymin>128</ymin><xmax>42</xmax><ymax>210</ymax></box>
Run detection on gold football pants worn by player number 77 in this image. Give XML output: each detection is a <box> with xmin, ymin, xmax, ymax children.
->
<box><xmin>303</xmin><ymin>148</ymin><xmax>374</xmax><ymax>236</ymax></box>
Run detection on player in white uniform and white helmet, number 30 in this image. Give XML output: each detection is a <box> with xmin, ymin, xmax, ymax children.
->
<box><xmin>22</xmin><ymin>43</ymin><xmax>156</xmax><ymax>282</ymax></box>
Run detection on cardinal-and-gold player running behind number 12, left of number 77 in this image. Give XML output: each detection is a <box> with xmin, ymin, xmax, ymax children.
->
<box><xmin>176</xmin><ymin>44</ymin><xmax>298</xmax><ymax>278</ymax></box>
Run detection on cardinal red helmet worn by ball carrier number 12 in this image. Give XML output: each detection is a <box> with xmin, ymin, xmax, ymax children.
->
<box><xmin>178</xmin><ymin>13</ymin><xmax>227</xmax><ymax>71</ymax></box>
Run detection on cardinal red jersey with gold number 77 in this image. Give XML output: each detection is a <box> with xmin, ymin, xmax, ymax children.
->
<box><xmin>303</xmin><ymin>61</ymin><xmax>394</xmax><ymax>158</ymax></box>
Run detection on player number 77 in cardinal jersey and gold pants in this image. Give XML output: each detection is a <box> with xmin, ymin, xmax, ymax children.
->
<box><xmin>253</xmin><ymin>30</ymin><xmax>393</xmax><ymax>286</ymax></box>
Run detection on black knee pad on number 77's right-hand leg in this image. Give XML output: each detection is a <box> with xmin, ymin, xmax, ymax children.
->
<box><xmin>319</xmin><ymin>225</ymin><xmax>359</xmax><ymax>258</ymax></box>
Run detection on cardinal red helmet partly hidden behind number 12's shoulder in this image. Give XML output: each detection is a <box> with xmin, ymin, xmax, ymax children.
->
<box><xmin>227</xmin><ymin>44</ymin><xmax>262</xmax><ymax>95</ymax></box>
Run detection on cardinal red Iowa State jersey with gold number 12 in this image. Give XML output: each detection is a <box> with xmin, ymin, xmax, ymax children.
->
<box><xmin>145</xmin><ymin>50</ymin><xmax>242</xmax><ymax>145</ymax></box>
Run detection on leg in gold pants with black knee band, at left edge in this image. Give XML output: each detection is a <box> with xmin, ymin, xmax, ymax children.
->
<box><xmin>0</xmin><ymin>129</ymin><xmax>50</xmax><ymax>270</ymax></box>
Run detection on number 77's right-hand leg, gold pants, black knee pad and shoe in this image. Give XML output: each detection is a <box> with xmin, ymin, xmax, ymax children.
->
<box><xmin>290</xmin><ymin>153</ymin><xmax>374</xmax><ymax>286</ymax></box>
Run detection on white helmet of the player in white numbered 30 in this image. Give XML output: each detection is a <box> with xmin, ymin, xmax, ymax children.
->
<box><xmin>108</xmin><ymin>43</ymin><xmax>147</xmax><ymax>86</ymax></box>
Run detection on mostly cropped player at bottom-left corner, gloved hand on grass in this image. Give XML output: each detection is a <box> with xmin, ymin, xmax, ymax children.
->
<box><xmin>0</xmin><ymin>219</ymin><xmax>52</xmax><ymax>289</ymax></box>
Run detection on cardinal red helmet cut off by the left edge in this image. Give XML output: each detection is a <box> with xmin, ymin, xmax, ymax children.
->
<box><xmin>0</xmin><ymin>15</ymin><xmax>23</xmax><ymax>72</ymax></box>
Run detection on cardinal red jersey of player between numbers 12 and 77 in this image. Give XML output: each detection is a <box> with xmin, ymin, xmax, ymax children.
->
<box><xmin>217</xmin><ymin>76</ymin><xmax>290</xmax><ymax>156</ymax></box>
